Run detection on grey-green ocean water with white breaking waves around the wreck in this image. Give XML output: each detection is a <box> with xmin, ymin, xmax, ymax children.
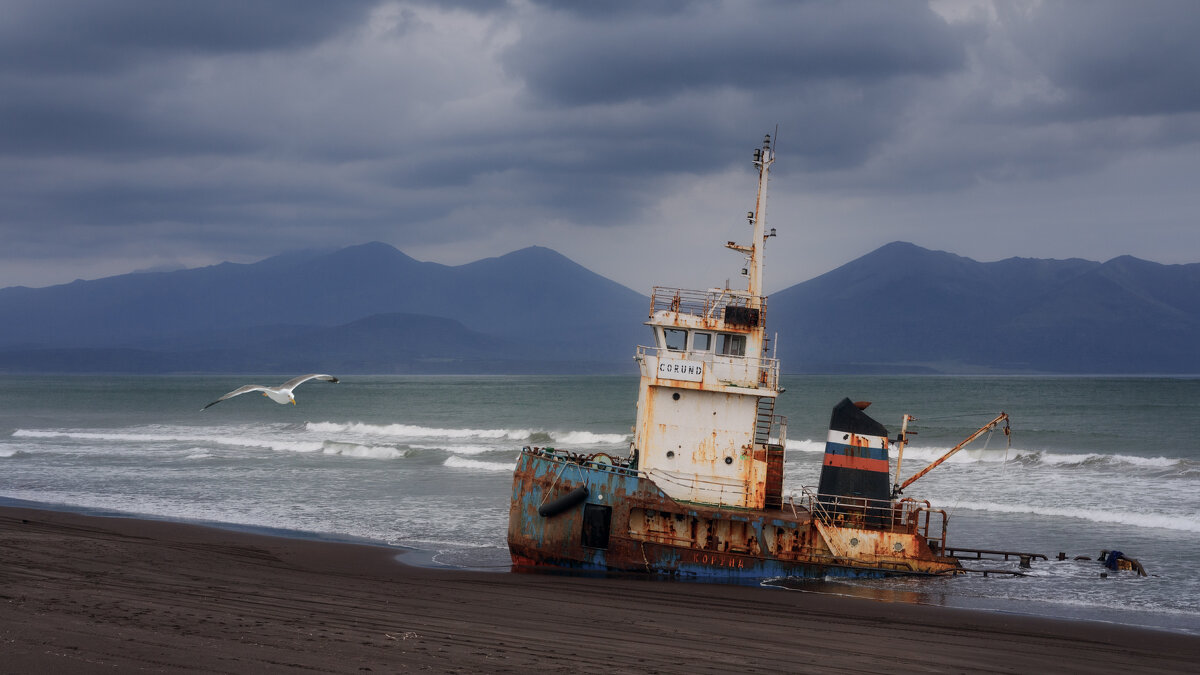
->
<box><xmin>0</xmin><ymin>376</ymin><xmax>1200</xmax><ymax>633</ymax></box>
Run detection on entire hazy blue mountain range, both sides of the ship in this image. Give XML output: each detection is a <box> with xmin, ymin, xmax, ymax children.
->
<box><xmin>0</xmin><ymin>243</ymin><xmax>1200</xmax><ymax>374</ymax></box>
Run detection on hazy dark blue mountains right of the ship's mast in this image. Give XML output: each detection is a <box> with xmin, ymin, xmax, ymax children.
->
<box><xmin>769</xmin><ymin>243</ymin><xmax>1200</xmax><ymax>374</ymax></box>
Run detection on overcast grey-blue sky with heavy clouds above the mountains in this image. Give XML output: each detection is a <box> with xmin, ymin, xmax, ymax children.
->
<box><xmin>0</xmin><ymin>0</ymin><xmax>1200</xmax><ymax>292</ymax></box>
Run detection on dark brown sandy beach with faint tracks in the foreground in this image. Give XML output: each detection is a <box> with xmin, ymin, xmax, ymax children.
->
<box><xmin>0</xmin><ymin>508</ymin><xmax>1200</xmax><ymax>673</ymax></box>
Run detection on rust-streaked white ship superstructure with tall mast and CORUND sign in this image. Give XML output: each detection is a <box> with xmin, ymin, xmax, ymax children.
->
<box><xmin>634</xmin><ymin>136</ymin><xmax>786</xmax><ymax>508</ymax></box>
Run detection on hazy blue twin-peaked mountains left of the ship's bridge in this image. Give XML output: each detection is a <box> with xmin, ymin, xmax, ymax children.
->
<box><xmin>0</xmin><ymin>243</ymin><xmax>647</xmax><ymax>372</ymax></box>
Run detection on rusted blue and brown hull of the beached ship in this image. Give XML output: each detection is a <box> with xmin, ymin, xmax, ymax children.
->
<box><xmin>508</xmin><ymin>448</ymin><xmax>960</xmax><ymax>583</ymax></box>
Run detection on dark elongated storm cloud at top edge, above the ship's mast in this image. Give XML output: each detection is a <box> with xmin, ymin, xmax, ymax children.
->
<box><xmin>506</xmin><ymin>2</ymin><xmax>964</xmax><ymax>106</ymax></box>
